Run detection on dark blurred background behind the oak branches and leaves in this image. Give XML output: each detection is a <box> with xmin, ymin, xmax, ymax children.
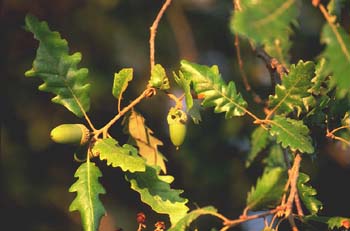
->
<box><xmin>0</xmin><ymin>0</ymin><xmax>350</xmax><ymax>231</ymax></box>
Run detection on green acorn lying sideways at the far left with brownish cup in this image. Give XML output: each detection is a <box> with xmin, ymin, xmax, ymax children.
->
<box><xmin>51</xmin><ymin>124</ymin><xmax>90</xmax><ymax>145</ymax></box>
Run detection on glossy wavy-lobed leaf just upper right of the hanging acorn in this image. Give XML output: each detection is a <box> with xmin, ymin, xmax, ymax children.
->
<box><xmin>181</xmin><ymin>60</ymin><xmax>247</xmax><ymax>119</ymax></box>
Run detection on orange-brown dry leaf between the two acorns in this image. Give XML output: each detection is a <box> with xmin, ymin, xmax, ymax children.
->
<box><xmin>124</xmin><ymin>110</ymin><xmax>166</xmax><ymax>173</ymax></box>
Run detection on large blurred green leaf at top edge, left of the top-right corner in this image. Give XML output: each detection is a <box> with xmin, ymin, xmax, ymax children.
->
<box><xmin>230</xmin><ymin>0</ymin><xmax>298</xmax><ymax>63</ymax></box>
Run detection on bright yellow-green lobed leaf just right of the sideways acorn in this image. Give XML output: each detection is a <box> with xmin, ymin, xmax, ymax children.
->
<box><xmin>92</xmin><ymin>138</ymin><xmax>146</xmax><ymax>172</ymax></box>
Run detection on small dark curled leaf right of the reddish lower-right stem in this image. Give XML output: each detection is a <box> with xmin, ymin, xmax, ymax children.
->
<box><xmin>297</xmin><ymin>172</ymin><xmax>322</xmax><ymax>214</ymax></box>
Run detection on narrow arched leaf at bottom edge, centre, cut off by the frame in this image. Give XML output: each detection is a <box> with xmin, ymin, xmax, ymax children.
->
<box><xmin>168</xmin><ymin>206</ymin><xmax>217</xmax><ymax>231</ymax></box>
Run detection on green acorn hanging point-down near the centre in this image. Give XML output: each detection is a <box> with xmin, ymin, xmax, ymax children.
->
<box><xmin>167</xmin><ymin>108</ymin><xmax>187</xmax><ymax>149</ymax></box>
